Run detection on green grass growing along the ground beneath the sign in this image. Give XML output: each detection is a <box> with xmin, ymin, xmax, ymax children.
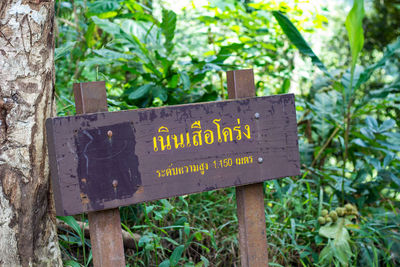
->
<box><xmin>59</xmin><ymin>175</ymin><xmax>400</xmax><ymax>267</ymax></box>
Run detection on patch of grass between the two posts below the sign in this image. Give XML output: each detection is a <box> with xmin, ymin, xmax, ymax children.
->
<box><xmin>117</xmin><ymin>190</ymin><xmax>234</xmax><ymax>266</ymax></box>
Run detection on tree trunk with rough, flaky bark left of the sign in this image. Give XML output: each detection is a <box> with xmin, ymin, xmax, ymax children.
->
<box><xmin>0</xmin><ymin>0</ymin><xmax>62</xmax><ymax>266</ymax></box>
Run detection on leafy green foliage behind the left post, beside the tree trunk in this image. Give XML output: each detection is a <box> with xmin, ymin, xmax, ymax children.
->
<box><xmin>56</xmin><ymin>0</ymin><xmax>241</xmax><ymax>114</ymax></box>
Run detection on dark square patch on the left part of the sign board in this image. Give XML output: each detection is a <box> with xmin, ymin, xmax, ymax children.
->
<box><xmin>75</xmin><ymin>122</ymin><xmax>142</xmax><ymax>213</ymax></box>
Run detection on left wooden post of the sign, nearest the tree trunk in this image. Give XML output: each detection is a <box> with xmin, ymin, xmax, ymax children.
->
<box><xmin>74</xmin><ymin>82</ymin><xmax>125</xmax><ymax>267</ymax></box>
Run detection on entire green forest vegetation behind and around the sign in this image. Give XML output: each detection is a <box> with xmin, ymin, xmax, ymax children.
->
<box><xmin>55</xmin><ymin>0</ymin><xmax>400</xmax><ymax>267</ymax></box>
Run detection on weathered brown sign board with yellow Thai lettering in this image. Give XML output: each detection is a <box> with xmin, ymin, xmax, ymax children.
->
<box><xmin>46</xmin><ymin>94</ymin><xmax>300</xmax><ymax>215</ymax></box>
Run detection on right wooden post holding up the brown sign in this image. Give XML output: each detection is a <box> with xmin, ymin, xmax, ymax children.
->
<box><xmin>226</xmin><ymin>69</ymin><xmax>268</xmax><ymax>267</ymax></box>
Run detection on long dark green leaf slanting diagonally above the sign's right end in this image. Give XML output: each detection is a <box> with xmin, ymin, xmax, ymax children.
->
<box><xmin>272</xmin><ymin>11</ymin><xmax>333</xmax><ymax>79</ymax></box>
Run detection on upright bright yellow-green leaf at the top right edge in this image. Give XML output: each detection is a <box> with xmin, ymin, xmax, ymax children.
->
<box><xmin>345</xmin><ymin>0</ymin><xmax>364</xmax><ymax>70</ymax></box>
